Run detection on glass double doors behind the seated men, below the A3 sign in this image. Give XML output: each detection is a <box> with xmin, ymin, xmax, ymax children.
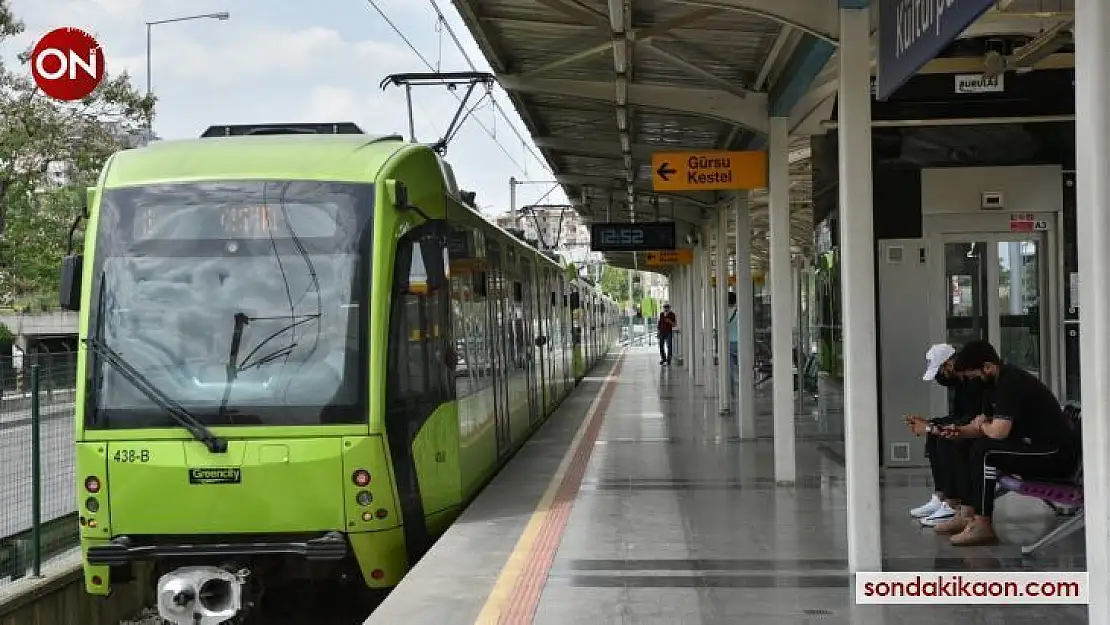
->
<box><xmin>944</xmin><ymin>232</ymin><xmax>1056</xmax><ymax>379</ymax></box>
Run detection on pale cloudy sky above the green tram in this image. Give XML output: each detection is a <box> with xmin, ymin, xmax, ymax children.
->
<box><xmin>0</xmin><ymin>0</ymin><xmax>566</xmax><ymax>215</ymax></box>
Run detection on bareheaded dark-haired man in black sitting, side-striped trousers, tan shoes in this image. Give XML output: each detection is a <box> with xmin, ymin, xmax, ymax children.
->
<box><xmin>936</xmin><ymin>341</ymin><xmax>1079</xmax><ymax>545</ymax></box>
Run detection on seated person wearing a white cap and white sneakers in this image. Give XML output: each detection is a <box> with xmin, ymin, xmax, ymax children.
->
<box><xmin>906</xmin><ymin>343</ymin><xmax>986</xmax><ymax>527</ymax></box>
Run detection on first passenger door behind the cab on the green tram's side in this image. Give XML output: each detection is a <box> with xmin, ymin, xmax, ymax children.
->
<box><xmin>486</xmin><ymin>243</ymin><xmax>513</xmax><ymax>458</ymax></box>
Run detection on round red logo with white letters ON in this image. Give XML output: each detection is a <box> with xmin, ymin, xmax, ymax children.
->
<box><xmin>31</xmin><ymin>27</ymin><xmax>104</xmax><ymax>101</ymax></box>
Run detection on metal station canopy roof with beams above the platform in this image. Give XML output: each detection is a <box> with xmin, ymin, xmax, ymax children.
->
<box><xmin>455</xmin><ymin>0</ymin><xmax>1073</xmax><ymax>270</ymax></box>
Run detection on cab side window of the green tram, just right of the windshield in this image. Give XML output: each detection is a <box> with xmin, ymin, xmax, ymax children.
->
<box><xmin>387</xmin><ymin>240</ymin><xmax>456</xmax><ymax>403</ymax></box>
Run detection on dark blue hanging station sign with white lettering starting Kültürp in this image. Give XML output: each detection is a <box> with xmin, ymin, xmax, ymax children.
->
<box><xmin>876</xmin><ymin>0</ymin><xmax>995</xmax><ymax>100</ymax></box>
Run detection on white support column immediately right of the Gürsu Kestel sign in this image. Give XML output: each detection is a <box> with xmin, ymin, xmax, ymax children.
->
<box><xmin>767</xmin><ymin>118</ymin><xmax>795</xmax><ymax>484</ymax></box>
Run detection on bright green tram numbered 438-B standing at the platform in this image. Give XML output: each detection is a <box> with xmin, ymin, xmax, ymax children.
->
<box><xmin>61</xmin><ymin>123</ymin><xmax>618</xmax><ymax>623</ymax></box>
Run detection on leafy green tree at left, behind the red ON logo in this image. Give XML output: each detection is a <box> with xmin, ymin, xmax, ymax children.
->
<box><xmin>0</xmin><ymin>0</ymin><xmax>154</xmax><ymax>304</ymax></box>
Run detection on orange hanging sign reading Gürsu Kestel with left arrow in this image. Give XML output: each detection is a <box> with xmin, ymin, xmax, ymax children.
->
<box><xmin>652</xmin><ymin>150</ymin><xmax>767</xmax><ymax>191</ymax></box>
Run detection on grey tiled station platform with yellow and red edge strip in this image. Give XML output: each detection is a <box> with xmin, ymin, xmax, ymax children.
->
<box><xmin>365</xmin><ymin>347</ymin><xmax>1087</xmax><ymax>625</ymax></box>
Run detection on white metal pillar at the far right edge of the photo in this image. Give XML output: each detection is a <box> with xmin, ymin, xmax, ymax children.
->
<box><xmin>1076</xmin><ymin>0</ymin><xmax>1110</xmax><ymax>625</ymax></box>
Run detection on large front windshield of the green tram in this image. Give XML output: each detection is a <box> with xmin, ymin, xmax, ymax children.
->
<box><xmin>85</xmin><ymin>181</ymin><xmax>373</xmax><ymax>429</ymax></box>
